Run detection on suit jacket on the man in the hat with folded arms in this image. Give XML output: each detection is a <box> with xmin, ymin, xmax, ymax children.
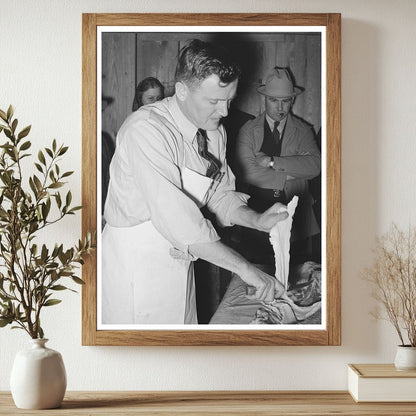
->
<box><xmin>236</xmin><ymin>113</ymin><xmax>321</xmax><ymax>239</ymax></box>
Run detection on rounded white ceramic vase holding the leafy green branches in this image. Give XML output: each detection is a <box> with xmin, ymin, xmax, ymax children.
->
<box><xmin>10</xmin><ymin>339</ymin><xmax>66</xmax><ymax>409</ymax></box>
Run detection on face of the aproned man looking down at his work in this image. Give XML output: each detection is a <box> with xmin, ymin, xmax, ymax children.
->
<box><xmin>176</xmin><ymin>75</ymin><xmax>238</xmax><ymax>130</ymax></box>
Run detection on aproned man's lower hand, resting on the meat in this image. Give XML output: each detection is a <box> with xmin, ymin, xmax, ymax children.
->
<box><xmin>244</xmin><ymin>266</ymin><xmax>285</xmax><ymax>302</ymax></box>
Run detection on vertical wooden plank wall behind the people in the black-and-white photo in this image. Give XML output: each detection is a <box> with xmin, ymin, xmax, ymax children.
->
<box><xmin>101</xmin><ymin>32</ymin><xmax>321</xmax><ymax>138</ymax></box>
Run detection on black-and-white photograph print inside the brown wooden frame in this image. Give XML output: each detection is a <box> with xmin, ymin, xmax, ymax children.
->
<box><xmin>97</xmin><ymin>27</ymin><xmax>325</xmax><ymax>329</ymax></box>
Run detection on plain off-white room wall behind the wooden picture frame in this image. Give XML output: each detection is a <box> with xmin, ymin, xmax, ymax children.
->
<box><xmin>0</xmin><ymin>0</ymin><xmax>416</xmax><ymax>390</ymax></box>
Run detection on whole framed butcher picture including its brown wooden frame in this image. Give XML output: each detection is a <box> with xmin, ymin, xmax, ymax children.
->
<box><xmin>82</xmin><ymin>13</ymin><xmax>341</xmax><ymax>346</ymax></box>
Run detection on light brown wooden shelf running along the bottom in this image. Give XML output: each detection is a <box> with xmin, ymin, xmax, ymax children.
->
<box><xmin>0</xmin><ymin>391</ymin><xmax>416</xmax><ymax>416</ymax></box>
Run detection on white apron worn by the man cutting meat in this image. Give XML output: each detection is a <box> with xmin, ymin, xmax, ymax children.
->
<box><xmin>102</xmin><ymin>167</ymin><xmax>213</xmax><ymax>325</ymax></box>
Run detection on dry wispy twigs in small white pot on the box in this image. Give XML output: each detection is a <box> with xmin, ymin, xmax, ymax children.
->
<box><xmin>363</xmin><ymin>224</ymin><xmax>416</xmax><ymax>370</ymax></box>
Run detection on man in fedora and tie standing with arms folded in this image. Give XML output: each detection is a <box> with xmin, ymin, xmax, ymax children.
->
<box><xmin>236</xmin><ymin>67</ymin><xmax>321</xmax><ymax>262</ymax></box>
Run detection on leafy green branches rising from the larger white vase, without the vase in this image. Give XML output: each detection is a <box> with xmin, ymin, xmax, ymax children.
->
<box><xmin>0</xmin><ymin>106</ymin><xmax>95</xmax><ymax>338</ymax></box>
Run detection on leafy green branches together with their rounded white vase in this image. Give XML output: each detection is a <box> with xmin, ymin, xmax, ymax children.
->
<box><xmin>0</xmin><ymin>106</ymin><xmax>93</xmax><ymax>409</ymax></box>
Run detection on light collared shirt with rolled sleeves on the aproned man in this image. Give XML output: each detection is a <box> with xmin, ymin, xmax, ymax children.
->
<box><xmin>104</xmin><ymin>96</ymin><xmax>247</xmax><ymax>253</ymax></box>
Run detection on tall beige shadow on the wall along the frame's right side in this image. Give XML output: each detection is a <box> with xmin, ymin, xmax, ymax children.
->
<box><xmin>340</xmin><ymin>19</ymin><xmax>382</xmax><ymax>359</ymax></box>
